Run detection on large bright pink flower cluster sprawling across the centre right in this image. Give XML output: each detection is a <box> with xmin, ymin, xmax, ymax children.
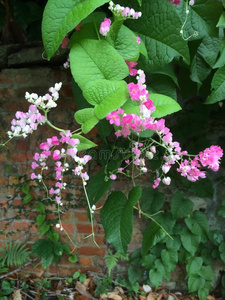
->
<box><xmin>106</xmin><ymin>62</ymin><xmax>223</xmax><ymax>189</ymax></box>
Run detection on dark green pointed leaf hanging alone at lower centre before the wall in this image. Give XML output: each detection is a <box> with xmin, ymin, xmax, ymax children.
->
<box><xmin>101</xmin><ymin>192</ymin><xmax>137</xmax><ymax>254</ymax></box>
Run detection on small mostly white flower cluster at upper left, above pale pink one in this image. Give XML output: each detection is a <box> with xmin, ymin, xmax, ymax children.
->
<box><xmin>25</xmin><ymin>82</ymin><xmax>62</xmax><ymax>111</ymax></box>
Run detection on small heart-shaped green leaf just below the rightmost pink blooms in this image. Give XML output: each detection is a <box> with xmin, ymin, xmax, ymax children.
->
<box><xmin>171</xmin><ymin>192</ymin><xmax>194</xmax><ymax>219</ymax></box>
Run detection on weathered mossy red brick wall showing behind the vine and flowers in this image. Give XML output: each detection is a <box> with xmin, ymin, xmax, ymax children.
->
<box><xmin>0</xmin><ymin>44</ymin><xmax>224</xmax><ymax>288</ymax></box>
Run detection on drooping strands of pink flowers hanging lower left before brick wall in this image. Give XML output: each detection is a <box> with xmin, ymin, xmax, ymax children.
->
<box><xmin>31</xmin><ymin>131</ymin><xmax>91</xmax><ymax>205</ymax></box>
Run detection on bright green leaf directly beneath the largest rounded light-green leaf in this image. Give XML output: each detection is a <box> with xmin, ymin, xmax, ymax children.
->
<box><xmin>83</xmin><ymin>80</ymin><xmax>128</xmax><ymax>119</ymax></box>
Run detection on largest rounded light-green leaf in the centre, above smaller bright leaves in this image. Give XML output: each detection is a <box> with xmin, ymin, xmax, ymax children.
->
<box><xmin>70</xmin><ymin>39</ymin><xmax>129</xmax><ymax>89</ymax></box>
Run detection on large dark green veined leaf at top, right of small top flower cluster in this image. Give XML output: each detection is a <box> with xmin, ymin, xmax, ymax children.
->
<box><xmin>123</xmin><ymin>0</ymin><xmax>189</xmax><ymax>69</ymax></box>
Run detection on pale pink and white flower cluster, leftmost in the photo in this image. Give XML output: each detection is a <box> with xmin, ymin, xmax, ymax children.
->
<box><xmin>7</xmin><ymin>105</ymin><xmax>46</xmax><ymax>138</ymax></box>
